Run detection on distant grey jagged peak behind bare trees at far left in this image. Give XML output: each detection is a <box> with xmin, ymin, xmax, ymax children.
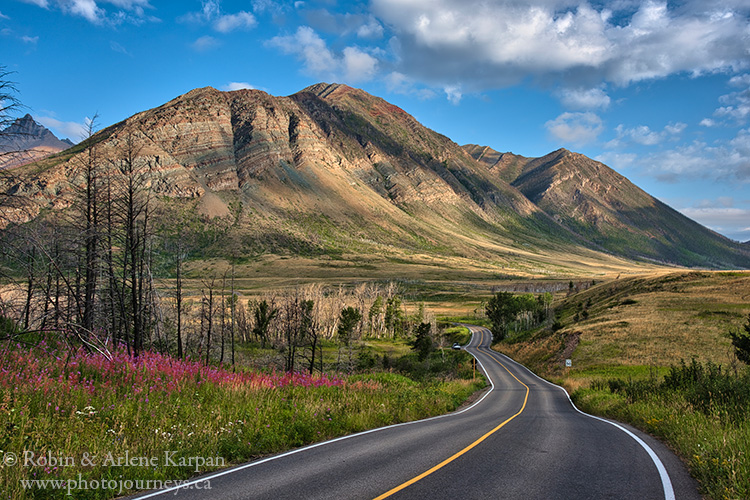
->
<box><xmin>0</xmin><ymin>114</ymin><xmax>73</xmax><ymax>168</ymax></box>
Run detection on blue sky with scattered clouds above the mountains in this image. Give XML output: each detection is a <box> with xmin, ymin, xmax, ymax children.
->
<box><xmin>0</xmin><ymin>0</ymin><xmax>750</xmax><ymax>241</ymax></box>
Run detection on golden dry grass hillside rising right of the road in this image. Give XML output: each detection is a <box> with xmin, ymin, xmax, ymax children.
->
<box><xmin>499</xmin><ymin>271</ymin><xmax>750</xmax><ymax>380</ymax></box>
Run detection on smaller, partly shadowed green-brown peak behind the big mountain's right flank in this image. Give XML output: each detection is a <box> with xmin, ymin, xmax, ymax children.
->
<box><xmin>465</xmin><ymin>145</ymin><xmax>749</xmax><ymax>267</ymax></box>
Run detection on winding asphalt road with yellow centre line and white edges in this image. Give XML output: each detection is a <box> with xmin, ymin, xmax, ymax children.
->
<box><xmin>133</xmin><ymin>327</ymin><xmax>701</xmax><ymax>500</ymax></box>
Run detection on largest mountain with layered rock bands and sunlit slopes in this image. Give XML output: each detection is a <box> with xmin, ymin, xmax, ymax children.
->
<box><xmin>4</xmin><ymin>84</ymin><xmax>595</xmax><ymax>267</ymax></box>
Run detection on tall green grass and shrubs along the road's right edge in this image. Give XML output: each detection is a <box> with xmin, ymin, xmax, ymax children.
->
<box><xmin>572</xmin><ymin>360</ymin><xmax>750</xmax><ymax>500</ymax></box>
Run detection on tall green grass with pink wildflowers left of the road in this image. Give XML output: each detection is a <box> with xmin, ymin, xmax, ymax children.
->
<box><xmin>0</xmin><ymin>345</ymin><xmax>483</xmax><ymax>499</ymax></box>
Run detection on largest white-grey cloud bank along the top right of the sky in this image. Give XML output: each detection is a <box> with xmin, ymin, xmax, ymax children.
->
<box><xmin>371</xmin><ymin>0</ymin><xmax>750</xmax><ymax>90</ymax></box>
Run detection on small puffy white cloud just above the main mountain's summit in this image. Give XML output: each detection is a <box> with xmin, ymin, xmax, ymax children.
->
<box><xmin>267</xmin><ymin>26</ymin><xmax>378</xmax><ymax>82</ymax></box>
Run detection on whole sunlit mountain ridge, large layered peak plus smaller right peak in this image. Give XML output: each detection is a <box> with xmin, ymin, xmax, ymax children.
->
<box><xmin>0</xmin><ymin>83</ymin><xmax>750</xmax><ymax>277</ymax></box>
